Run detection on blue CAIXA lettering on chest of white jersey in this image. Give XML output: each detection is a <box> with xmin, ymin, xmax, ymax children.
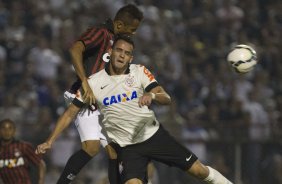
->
<box><xmin>103</xmin><ymin>91</ymin><xmax>137</xmax><ymax>106</ymax></box>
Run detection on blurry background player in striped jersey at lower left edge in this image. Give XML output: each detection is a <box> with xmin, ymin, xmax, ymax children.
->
<box><xmin>0</xmin><ymin>119</ymin><xmax>45</xmax><ymax>184</ymax></box>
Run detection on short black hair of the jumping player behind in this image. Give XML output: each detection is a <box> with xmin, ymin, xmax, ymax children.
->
<box><xmin>114</xmin><ymin>4</ymin><xmax>144</xmax><ymax>25</ymax></box>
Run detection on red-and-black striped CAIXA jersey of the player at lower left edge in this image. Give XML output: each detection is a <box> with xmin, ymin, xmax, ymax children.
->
<box><xmin>0</xmin><ymin>140</ymin><xmax>41</xmax><ymax>184</ymax></box>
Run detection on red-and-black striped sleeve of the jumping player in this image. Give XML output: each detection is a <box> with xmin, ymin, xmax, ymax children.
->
<box><xmin>78</xmin><ymin>27</ymin><xmax>107</xmax><ymax>50</ymax></box>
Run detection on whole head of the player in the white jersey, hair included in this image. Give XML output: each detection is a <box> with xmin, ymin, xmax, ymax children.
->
<box><xmin>109</xmin><ymin>34</ymin><xmax>134</xmax><ymax>74</ymax></box>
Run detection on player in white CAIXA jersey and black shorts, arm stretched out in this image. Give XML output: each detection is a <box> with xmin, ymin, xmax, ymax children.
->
<box><xmin>36</xmin><ymin>35</ymin><xmax>234</xmax><ymax>184</ymax></box>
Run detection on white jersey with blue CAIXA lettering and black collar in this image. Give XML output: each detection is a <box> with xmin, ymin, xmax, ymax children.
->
<box><xmin>78</xmin><ymin>64</ymin><xmax>159</xmax><ymax>147</ymax></box>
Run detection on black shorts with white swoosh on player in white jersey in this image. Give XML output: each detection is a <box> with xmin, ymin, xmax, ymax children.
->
<box><xmin>119</xmin><ymin>126</ymin><xmax>198</xmax><ymax>183</ymax></box>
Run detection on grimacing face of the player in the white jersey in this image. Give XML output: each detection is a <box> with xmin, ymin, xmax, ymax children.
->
<box><xmin>110</xmin><ymin>40</ymin><xmax>133</xmax><ymax>74</ymax></box>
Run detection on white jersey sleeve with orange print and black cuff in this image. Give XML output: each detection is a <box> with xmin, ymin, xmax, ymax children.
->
<box><xmin>139</xmin><ymin>66</ymin><xmax>159</xmax><ymax>92</ymax></box>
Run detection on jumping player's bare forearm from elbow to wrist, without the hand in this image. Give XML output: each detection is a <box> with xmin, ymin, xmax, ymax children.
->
<box><xmin>70</xmin><ymin>41</ymin><xmax>87</xmax><ymax>81</ymax></box>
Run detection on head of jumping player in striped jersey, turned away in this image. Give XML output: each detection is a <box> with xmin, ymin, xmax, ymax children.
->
<box><xmin>114</xmin><ymin>4</ymin><xmax>143</xmax><ymax>34</ymax></box>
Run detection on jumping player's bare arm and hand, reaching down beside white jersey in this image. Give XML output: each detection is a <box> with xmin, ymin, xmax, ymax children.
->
<box><xmin>70</xmin><ymin>41</ymin><xmax>95</xmax><ymax>105</ymax></box>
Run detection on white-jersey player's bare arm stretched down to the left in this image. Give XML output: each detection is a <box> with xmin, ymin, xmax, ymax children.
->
<box><xmin>35</xmin><ymin>104</ymin><xmax>80</xmax><ymax>154</ymax></box>
